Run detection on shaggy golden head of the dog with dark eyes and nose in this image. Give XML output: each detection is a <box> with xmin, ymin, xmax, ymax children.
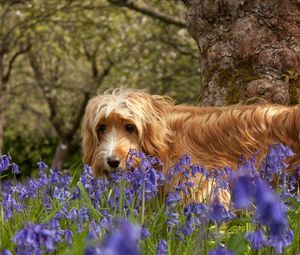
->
<box><xmin>83</xmin><ymin>89</ymin><xmax>173</xmax><ymax>176</ymax></box>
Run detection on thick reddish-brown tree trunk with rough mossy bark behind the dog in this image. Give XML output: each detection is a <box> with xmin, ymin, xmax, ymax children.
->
<box><xmin>183</xmin><ymin>0</ymin><xmax>300</xmax><ymax>105</ymax></box>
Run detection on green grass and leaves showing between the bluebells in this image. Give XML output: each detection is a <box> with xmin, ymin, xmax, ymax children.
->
<box><xmin>0</xmin><ymin>167</ymin><xmax>300</xmax><ymax>255</ymax></box>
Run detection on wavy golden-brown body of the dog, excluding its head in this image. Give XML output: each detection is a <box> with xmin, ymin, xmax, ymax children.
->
<box><xmin>168</xmin><ymin>102</ymin><xmax>300</xmax><ymax>172</ymax></box>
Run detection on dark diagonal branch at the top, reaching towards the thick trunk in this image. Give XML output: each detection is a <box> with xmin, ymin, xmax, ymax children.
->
<box><xmin>107</xmin><ymin>0</ymin><xmax>186</xmax><ymax>28</ymax></box>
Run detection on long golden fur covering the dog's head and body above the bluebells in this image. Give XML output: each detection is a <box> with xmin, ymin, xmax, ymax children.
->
<box><xmin>83</xmin><ymin>89</ymin><xmax>300</xmax><ymax>202</ymax></box>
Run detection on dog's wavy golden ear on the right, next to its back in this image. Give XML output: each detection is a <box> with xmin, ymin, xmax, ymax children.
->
<box><xmin>141</xmin><ymin>96</ymin><xmax>173</xmax><ymax>158</ymax></box>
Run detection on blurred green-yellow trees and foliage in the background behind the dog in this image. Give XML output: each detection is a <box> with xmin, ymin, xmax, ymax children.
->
<box><xmin>0</xmin><ymin>0</ymin><xmax>200</xmax><ymax>174</ymax></box>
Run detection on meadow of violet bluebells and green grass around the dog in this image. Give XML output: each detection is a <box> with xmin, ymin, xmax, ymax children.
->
<box><xmin>0</xmin><ymin>144</ymin><xmax>300</xmax><ymax>255</ymax></box>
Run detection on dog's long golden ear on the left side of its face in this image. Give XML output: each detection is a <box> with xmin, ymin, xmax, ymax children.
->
<box><xmin>82</xmin><ymin>99</ymin><xmax>97</xmax><ymax>165</ymax></box>
